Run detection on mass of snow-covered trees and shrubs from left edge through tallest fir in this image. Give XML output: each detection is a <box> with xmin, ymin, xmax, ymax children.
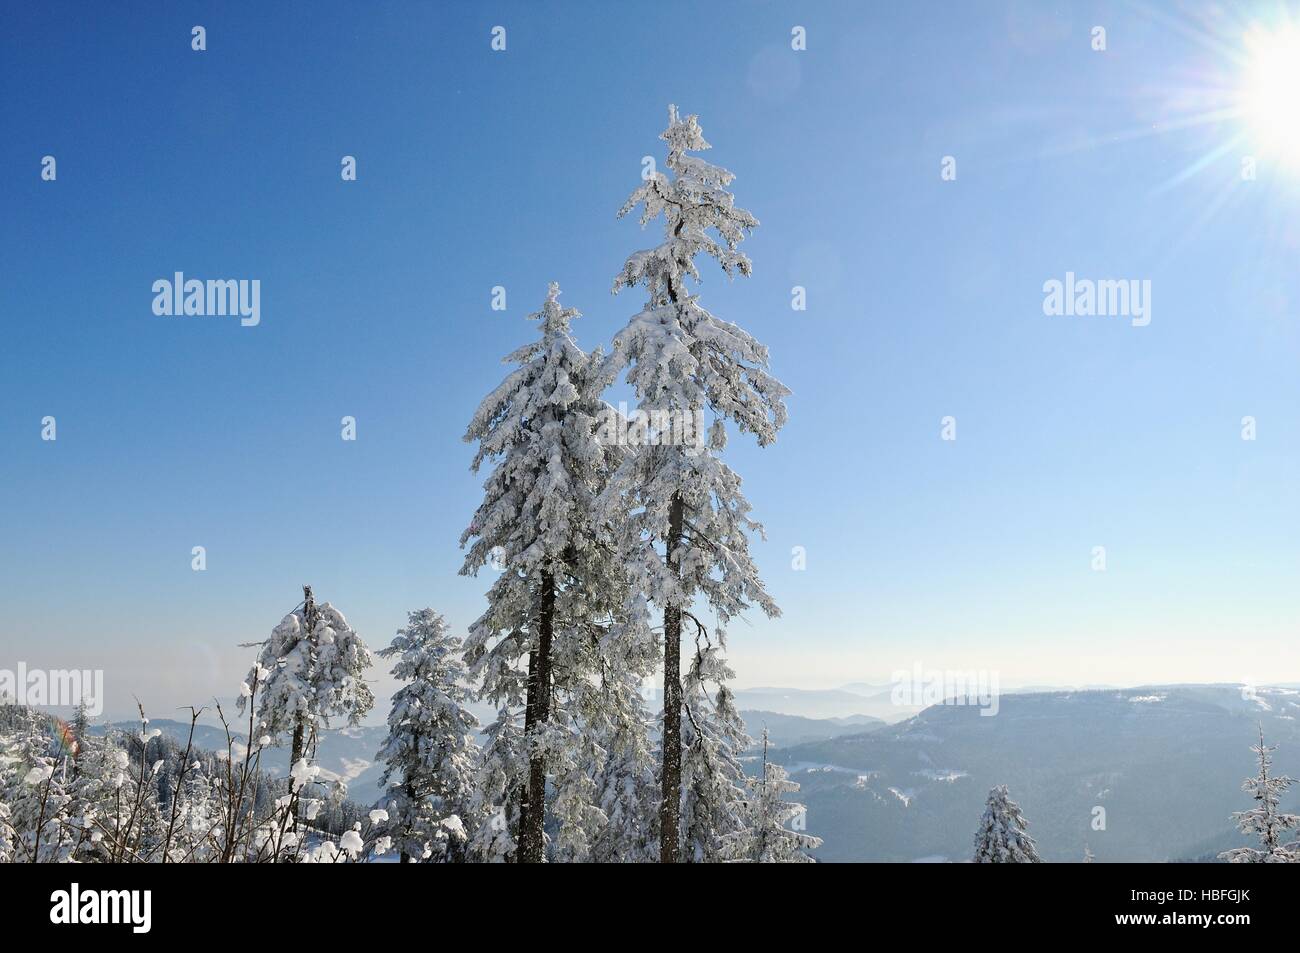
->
<box><xmin>0</xmin><ymin>107</ymin><xmax>820</xmax><ymax>862</ymax></box>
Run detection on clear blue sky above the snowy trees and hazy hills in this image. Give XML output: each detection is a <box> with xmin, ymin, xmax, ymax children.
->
<box><xmin>0</xmin><ymin>0</ymin><xmax>1300</xmax><ymax>714</ymax></box>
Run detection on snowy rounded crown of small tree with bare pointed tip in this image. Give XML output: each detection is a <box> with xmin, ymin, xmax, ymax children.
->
<box><xmin>238</xmin><ymin>586</ymin><xmax>374</xmax><ymax>767</ymax></box>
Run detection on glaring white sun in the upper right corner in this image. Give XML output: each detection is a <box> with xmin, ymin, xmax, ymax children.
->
<box><xmin>1240</xmin><ymin>23</ymin><xmax>1300</xmax><ymax>169</ymax></box>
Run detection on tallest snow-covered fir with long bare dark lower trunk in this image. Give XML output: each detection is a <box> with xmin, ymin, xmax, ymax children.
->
<box><xmin>606</xmin><ymin>107</ymin><xmax>789</xmax><ymax>862</ymax></box>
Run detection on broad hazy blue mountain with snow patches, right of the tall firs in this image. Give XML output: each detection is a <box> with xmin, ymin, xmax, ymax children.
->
<box><xmin>781</xmin><ymin>685</ymin><xmax>1300</xmax><ymax>862</ymax></box>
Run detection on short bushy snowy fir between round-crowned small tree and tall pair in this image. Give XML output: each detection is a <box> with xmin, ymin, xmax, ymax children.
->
<box><xmin>376</xmin><ymin>608</ymin><xmax>478</xmax><ymax>863</ymax></box>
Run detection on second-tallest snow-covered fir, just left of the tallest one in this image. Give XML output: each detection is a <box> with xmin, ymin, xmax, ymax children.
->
<box><xmin>460</xmin><ymin>283</ymin><xmax>627</xmax><ymax>862</ymax></box>
